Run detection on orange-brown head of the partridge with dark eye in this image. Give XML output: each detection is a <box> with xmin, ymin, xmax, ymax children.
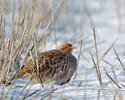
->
<box><xmin>59</xmin><ymin>43</ymin><xmax>73</xmax><ymax>54</ymax></box>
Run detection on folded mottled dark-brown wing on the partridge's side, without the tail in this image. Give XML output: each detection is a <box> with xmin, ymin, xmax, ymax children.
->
<box><xmin>38</xmin><ymin>50</ymin><xmax>66</xmax><ymax>72</ymax></box>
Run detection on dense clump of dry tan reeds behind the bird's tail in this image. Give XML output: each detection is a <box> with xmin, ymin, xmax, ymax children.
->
<box><xmin>0</xmin><ymin>0</ymin><xmax>67</xmax><ymax>98</ymax></box>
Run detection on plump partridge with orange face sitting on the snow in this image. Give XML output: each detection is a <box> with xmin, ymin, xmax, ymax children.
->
<box><xmin>11</xmin><ymin>42</ymin><xmax>77</xmax><ymax>85</ymax></box>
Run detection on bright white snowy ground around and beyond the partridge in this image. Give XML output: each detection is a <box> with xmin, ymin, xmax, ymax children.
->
<box><xmin>0</xmin><ymin>0</ymin><xmax>125</xmax><ymax>100</ymax></box>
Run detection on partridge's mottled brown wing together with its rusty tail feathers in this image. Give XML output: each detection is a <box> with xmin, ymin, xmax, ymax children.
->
<box><xmin>13</xmin><ymin>50</ymin><xmax>65</xmax><ymax>79</ymax></box>
